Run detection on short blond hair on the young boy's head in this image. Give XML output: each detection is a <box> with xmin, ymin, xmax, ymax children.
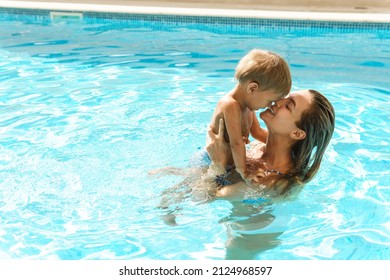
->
<box><xmin>234</xmin><ymin>49</ymin><xmax>292</xmax><ymax>97</ymax></box>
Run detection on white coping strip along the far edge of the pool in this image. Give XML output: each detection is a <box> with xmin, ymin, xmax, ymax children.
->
<box><xmin>0</xmin><ymin>1</ymin><xmax>390</xmax><ymax>23</ymax></box>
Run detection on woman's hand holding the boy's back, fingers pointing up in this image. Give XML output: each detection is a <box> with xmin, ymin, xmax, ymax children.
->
<box><xmin>206</xmin><ymin>118</ymin><xmax>232</xmax><ymax>168</ymax></box>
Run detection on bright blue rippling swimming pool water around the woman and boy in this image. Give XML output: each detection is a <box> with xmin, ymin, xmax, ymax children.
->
<box><xmin>0</xmin><ymin>9</ymin><xmax>390</xmax><ymax>260</ymax></box>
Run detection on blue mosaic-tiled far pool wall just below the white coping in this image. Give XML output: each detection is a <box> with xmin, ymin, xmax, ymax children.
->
<box><xmin>0</xmin><ymin>7</ymin><xmax>390</xmax><ymax>34</ymax></box>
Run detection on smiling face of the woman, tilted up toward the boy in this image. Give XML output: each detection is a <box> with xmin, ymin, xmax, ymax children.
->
<box><xmin>260</xmin><ymin>90</ymin><xmax>313</xmax><ymax>134</ymax></box>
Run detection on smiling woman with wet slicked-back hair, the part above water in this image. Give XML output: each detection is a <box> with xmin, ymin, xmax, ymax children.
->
<box><xmin>206</xmin><ymin>90</ymin><xmax>335</xmax><ymax>201</ymax></box>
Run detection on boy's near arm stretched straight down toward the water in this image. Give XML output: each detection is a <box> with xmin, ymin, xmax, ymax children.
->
<box><xmin>222</xmin><ymin>101</ymin><xmax>246</xmax><ymax>178</ymax></box>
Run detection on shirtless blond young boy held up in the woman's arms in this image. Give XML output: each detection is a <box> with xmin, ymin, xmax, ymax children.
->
<box><xmin>210</xmin><ymin>49</ymin><xmax>292</xmax><ymax>179</ymax></box>
